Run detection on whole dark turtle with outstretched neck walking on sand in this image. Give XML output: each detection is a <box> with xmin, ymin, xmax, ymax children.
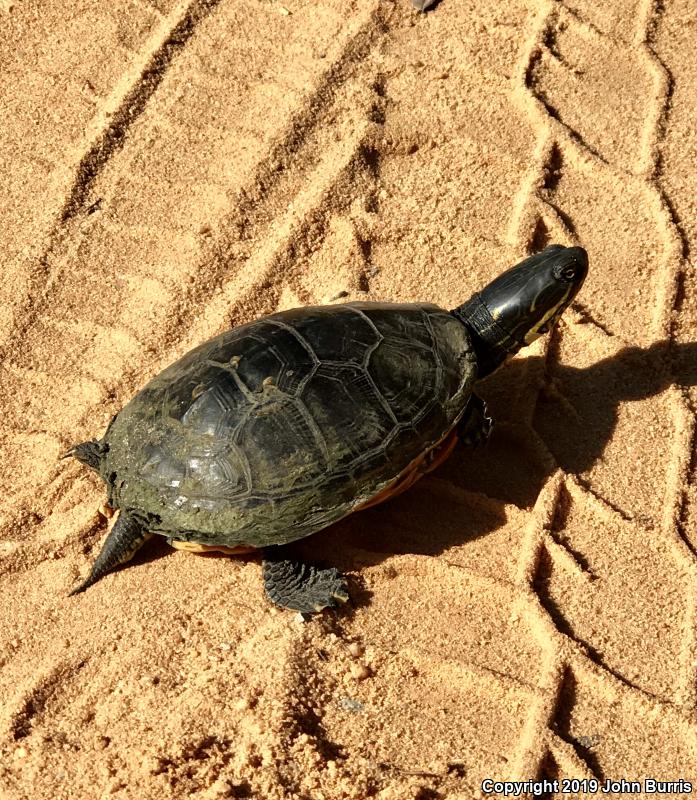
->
<box><xmin>64</xmin><ymin>245</ymin><xmax>588</xmax><ymax>615</ymax></box>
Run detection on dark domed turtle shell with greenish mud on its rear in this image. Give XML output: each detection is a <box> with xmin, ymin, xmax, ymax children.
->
<box><xmin>100</xmin><ymin>303</ymin><xmax>476</xmax><ymax>547</ymax></box>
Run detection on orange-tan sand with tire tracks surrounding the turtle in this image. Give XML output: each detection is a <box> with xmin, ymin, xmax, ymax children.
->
<box><xmin>0</xmin><ymin>0</ymin><xmax>697</xmax><ymax>800</ymax></box>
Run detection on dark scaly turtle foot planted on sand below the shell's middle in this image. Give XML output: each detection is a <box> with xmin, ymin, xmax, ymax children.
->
<box><xmin>262</xmin><ymin>546</ymin><xmax>348</xmax><ymax>614</ymax></box>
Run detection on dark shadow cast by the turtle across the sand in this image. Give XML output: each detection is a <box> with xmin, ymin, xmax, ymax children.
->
<box><xmin>308</xmin><ymin>342</ymin><xmax>697</xmax><ymax>605</ymax></box>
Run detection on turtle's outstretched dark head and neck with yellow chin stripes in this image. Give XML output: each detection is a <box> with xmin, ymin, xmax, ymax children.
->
<box><xmin>451</xmin><ymin>244</ymin><xmax>588</xmax><ymax>377</ymax></box>
